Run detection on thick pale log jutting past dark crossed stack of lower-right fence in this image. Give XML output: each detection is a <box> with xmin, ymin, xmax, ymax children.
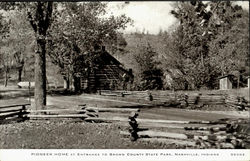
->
<box><xmin>120</xmin><ymin>130</ymin><xmax>188</xmax><ymax>140</ymax></box>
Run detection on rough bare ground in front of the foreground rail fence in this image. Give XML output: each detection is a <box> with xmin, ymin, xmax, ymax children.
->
<box><xmin>0</xmin><ymin>120</ymin><xmax>180</xmax><ymax>149</ymax></box>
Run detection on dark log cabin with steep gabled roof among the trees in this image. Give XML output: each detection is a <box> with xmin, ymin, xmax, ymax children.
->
<box><xmin>79</xmin><ymin>47</ymin><xmax>134</xmax><ymax>93</ymax></box>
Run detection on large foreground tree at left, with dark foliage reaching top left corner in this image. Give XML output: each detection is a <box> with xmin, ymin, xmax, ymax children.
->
<box><xmin>0</xmin><ymin>1</ymin><xmax>53</xmax><ymax>109</ymax></box>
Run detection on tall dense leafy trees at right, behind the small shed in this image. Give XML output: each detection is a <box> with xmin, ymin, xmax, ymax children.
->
<box><xmin>165</xmin><ymin>1</ymin><xmax>249</xmax><ymax>89</ymax></box>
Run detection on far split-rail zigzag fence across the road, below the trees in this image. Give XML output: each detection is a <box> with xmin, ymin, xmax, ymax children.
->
<box><xmin>96</xmin><ymin>90</ymin><xmax>250</xmax><ymax>110</ymax></box>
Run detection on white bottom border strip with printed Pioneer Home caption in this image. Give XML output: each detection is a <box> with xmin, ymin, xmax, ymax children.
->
<box><xmin>0</xmin><ymin>149</ymin><xmax>250</xmax><ymax>161</ymax></box>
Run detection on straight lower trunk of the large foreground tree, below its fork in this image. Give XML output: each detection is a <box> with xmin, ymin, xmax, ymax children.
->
<box><xmin>35</xmin><ymin>36</ymin><xmax>46</xmax><ymax>109</ymax></box>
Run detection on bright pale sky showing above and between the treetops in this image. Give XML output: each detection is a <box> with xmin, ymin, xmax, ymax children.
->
<box><xmin>108</xmin><ymin>1</ymin><xmax>249</xmax><ymax>34</ymax></box>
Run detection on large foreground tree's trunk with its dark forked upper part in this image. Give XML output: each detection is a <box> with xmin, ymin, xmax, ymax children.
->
<box><xmin>27</xmin><ymin>1</ymin><xmax>53</xmax><ymax>109</ymax></box>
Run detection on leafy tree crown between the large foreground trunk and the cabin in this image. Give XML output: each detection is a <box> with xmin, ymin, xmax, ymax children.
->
<box><xmin>49</xmin><ymin>2</ymin><xmax>131</xmax><ymax>90</ymax></box>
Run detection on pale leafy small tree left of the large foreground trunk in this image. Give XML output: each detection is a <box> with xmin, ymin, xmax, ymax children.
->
<box><xmin>6</xmin><ymin>10</ymin><xmax>35</xmax><ymax>81</ymax></box>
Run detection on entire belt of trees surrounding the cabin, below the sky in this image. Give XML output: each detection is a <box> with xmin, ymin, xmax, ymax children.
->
<box><xmin>0</xmin><ymin>1</ymin><xmax>250</xmax><ymax>107</ymax></box>
